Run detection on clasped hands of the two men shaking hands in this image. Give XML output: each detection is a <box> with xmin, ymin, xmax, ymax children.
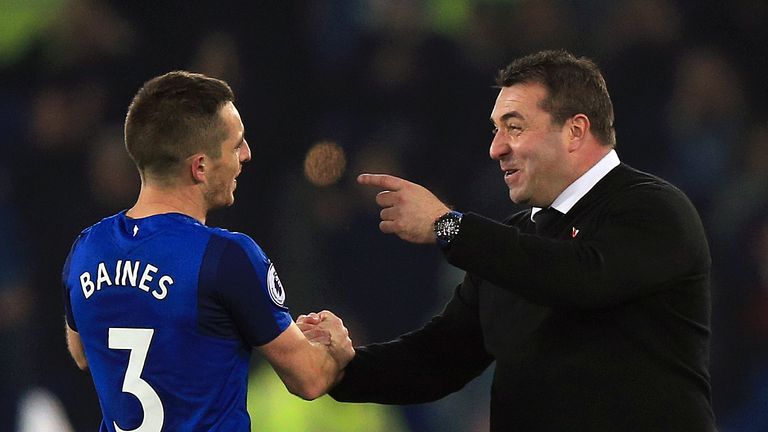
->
<box><xmin>296</xmin><ymin>310</ymin><xmax>355</xmax><ymax>370</ymax></box>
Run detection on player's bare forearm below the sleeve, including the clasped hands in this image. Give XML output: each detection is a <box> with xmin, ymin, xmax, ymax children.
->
<box><xmin>258</xmin><ymin>311</ymin><xmax>355</xmax><ymax>400</ymax></box>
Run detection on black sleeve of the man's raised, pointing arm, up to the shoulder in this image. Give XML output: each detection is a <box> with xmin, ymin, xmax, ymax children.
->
<box><xmin>446</xmin><ymin>186</ymin><xmax>710</xmax><ymax>308</ymax></box>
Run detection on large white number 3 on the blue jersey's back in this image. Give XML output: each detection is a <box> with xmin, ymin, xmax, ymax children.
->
<box><xmin>109</xmin><ymin>328</ymin><xmax>165</xmax><ymax>432</ymax></box>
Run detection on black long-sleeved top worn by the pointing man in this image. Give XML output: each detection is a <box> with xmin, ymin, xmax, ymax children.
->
<box><xmin>331</xmin><ymin>164</ymin><xmax>714</xmax><ymax>431</ymax></box>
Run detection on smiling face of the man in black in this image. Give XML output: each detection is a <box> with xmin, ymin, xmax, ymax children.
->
<box><xmin>490</xmin><ymin>83</ymin><xmax>570</xmax><ymax>207</ymax></box>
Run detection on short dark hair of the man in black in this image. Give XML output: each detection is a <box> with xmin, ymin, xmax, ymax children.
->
<box><xmin>496</xmin><ymin>50</ymin><xmax>616</xmax><ymax>147</ymax></box>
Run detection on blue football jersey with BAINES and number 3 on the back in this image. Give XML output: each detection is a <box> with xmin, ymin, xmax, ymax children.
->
<box><xmin>63</xmin><ymin>212</ymin><xmax>292</xmax><ymax>432</ymax></box>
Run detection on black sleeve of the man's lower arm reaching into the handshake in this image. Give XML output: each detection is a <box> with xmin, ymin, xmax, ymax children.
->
<box><xmin>330</xmin><ymin>276</ymin><xmax>493</xmax><ymax>404</ymax></box>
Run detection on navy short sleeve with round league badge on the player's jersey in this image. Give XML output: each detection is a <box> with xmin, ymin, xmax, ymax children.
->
<box><xmin>199</xmin><ymin>234</ymin><xmax>293</xmax><ymax>346</ymax></box>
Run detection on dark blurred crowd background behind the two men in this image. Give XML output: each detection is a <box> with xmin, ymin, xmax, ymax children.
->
<box><xmin>0</xmin><ymin>0</ymin><xmax>768</xmax><ymax>432</ymax></box>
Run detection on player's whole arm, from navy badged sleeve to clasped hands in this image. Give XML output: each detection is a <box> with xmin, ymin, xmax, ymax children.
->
<box><xmin>210</xmin><ymin>234</ymin><xmax>354</xmax><ymax>399</ymax></box>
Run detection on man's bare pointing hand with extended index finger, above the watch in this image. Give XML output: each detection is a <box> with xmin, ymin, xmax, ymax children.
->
<box><xmin>357</xmin><ymin>174</ymin><xmax>451</xmax><ymax>243</ymax></box>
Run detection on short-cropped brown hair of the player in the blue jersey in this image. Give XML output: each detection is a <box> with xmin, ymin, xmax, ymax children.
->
<box><xmin>125</xmin><ymin>71</ymin><xmax>235</xmax><ymax>179</ymax></box>
